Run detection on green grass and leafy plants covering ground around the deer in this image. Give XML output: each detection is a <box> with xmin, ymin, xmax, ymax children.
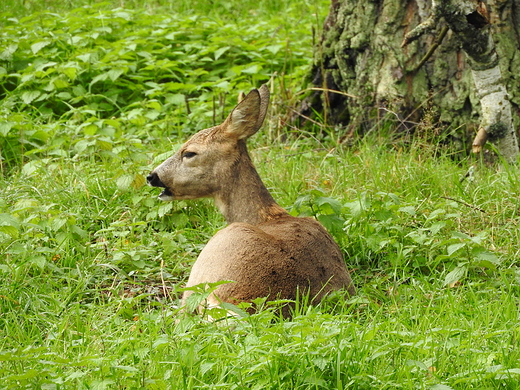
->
<box><xmin>0</xmin><ymin>0</ymin><xmax>520</xmax><ymax>390</ymax></box>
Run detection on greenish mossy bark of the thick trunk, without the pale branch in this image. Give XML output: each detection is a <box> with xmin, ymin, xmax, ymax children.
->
<box><xmin>307</xmin><ymin>0</ymin><xmax>520</xmax><ymax>148</ymax></box>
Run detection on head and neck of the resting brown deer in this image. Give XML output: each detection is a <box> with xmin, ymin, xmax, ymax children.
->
<box><xmin>147</xmin><ymin>85</ymin><xmax>285</xmax><ymax>223</ymax></box>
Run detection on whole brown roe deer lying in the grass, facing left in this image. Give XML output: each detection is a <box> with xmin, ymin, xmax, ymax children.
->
<box><xmin>147</xmin><ymin>85</ymin><xmax>355</xmax><ymax>315</ymax></box>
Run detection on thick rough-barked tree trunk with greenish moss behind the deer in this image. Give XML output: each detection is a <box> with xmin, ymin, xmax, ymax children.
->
<box><xmin>302</xmin><ymin>0</ymin><xmax>520</xmax><ymax>161</ymax></box>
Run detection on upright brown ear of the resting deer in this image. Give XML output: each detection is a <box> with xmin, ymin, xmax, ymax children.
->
<box><xmin>223</xmin><ymin>84</ymin><xmax>269</xmax><ymax>139</ymax></box>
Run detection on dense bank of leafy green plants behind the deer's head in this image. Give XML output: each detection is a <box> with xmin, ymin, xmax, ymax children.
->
<box><xmin>0</xmin><ymin>5</ymin><xmax>312</xmax><ymax>172</ymax></box>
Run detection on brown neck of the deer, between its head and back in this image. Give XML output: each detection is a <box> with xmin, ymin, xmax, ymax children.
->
<box><xmin>214</xmin><ymin>144</ymin><xmax>288</xmax><ymax>225</ymax></box>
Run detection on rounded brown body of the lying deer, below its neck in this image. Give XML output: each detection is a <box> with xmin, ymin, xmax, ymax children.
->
<box><xmin>183</xmin><ymin>216</ymin><xmax>351</xmax><ymax>305</ymax></box>
